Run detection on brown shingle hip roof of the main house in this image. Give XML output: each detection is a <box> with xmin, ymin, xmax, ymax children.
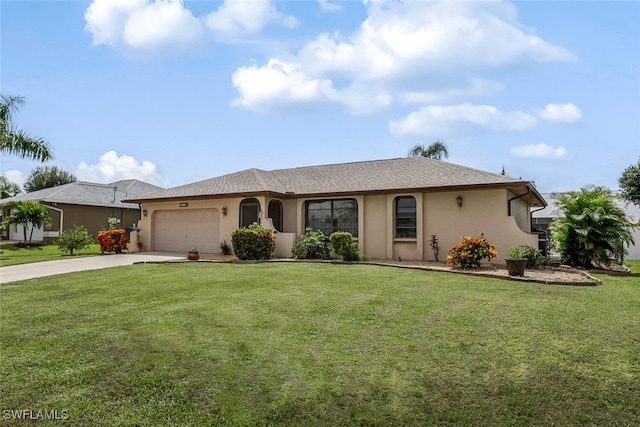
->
<box><xmin>129</xmin><ymin>157</ymin><xmax>542</xmax><ymax>206</ymax></box>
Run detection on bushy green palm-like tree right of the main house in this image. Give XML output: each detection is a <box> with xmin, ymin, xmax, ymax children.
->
<box><xmin>549</xmin><ymin>186</ymin><xmax>635</xmax><ymax>268</ymax></box>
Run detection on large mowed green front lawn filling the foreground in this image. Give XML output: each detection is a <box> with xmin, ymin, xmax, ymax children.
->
<box><xmin>0</xmin><ymin>263</ymin><xmax>640</xmax><ymax>426</ymax></box>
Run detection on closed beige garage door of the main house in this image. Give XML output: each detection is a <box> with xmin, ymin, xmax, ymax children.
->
<box><xmin>153</xmin><ymin>209</ymin><xmax>220</xmax><ymax>253</ymax></box>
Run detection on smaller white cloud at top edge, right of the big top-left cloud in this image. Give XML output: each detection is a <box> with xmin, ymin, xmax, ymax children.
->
<box><xmin>205</xmin><ymin>0</ymin><xmax>298</xmax><ymax>36</ymax></box>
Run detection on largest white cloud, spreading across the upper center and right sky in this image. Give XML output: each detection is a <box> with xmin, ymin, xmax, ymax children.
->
<box><xmin>234</xmin><ymin>0</ymin><xmax>575</xmax><ymax>111</ymax></box>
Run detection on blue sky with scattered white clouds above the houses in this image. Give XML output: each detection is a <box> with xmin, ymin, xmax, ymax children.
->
<box><xmin>0</xmin><ymin>0</ymin><xmax>640</xmax><ymax>192</ymax></box>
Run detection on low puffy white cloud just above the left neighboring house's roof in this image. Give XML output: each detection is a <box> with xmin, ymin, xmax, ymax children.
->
<box><xmin>75</xmin><ymin>150</ymin><xmax>164</xmax><ymax>185</ymax></box>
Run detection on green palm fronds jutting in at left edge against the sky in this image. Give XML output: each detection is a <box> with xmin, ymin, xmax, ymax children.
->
<box><xmin>0</xmin><ymin>95</ymin><xmax>53</xmax><ymax>162</ymax></box>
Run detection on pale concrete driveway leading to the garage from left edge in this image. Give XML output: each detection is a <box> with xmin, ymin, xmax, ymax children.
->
<box><xmin>0</xmin><ymin>252</ymin><xmax>186</xmax><ymax>283</ymax></box>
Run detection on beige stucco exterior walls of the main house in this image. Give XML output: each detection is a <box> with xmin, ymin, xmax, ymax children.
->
<box><xmin>139</xmin><ymin>189</ymin><xmax>537</xmax><ymax>263</ymax></box>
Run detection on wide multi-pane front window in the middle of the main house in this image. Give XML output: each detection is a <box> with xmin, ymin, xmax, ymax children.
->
<box><xmin>305</xmin><ymin>199</ymin><xmax>358</xmax><ymax>237</ymax></box>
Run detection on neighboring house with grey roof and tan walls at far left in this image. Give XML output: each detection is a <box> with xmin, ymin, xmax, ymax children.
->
<box><xmin>0</xmin><ymin>179</ymin><xmax>162</xmax><ymax>241</ymax></box>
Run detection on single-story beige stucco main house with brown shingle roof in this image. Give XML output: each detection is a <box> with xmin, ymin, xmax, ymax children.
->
<box><xmin>126</xmin><ymin>157</ymin><xmax>546</xmax><ymax>260</ymax></box>
